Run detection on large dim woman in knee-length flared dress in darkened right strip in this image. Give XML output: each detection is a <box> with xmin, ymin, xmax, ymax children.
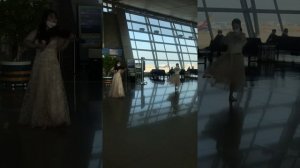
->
<box><xmin>204</xmin><ymin>19</ymin><xmax>247</xmax><ymax>102</ymax></box>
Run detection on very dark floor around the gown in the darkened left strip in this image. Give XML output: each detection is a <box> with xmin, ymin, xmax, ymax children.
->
<box><xmin>0</xmin><ymin>71</ymin><xmax>103</xmax><ymax>168</ymax></box>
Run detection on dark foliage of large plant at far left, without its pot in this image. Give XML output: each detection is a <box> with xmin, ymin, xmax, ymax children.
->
<box><xmin>0</xmin><ymin>0</ymin><xmax>50</xmax><ymax>61</ymax></box>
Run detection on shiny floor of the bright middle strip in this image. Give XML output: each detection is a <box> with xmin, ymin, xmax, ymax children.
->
<box><xmin>103</xmin><ymin>78</ymin><xmax>198</xmax><ymax>168</ymax></box>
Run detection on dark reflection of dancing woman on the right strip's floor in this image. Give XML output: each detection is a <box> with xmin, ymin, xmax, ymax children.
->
<box><xmin>203</xmin><ymin>108</ymin><xmax>244</xmax><ymax>168</ymax></box>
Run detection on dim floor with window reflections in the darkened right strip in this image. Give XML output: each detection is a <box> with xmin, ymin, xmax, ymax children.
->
<box><xmin>197</xmin><ymin>57</ymin><xmax>300</xmax><ymax>168</ymax></box>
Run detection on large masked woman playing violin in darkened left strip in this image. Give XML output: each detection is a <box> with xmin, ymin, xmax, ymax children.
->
<box><xmin>19</xmin><ymin>10</ymin><xmax>71</xmax><ymax>128</ymax></box>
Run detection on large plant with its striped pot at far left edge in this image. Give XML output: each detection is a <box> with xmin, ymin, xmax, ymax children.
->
<box><xmin>0</xmin><ymin>0</ymin><xmax>50</xmax><ymax>89</ymax></box>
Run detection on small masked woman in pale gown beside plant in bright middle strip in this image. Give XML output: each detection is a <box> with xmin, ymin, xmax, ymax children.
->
<box><xmin>109</xmin><ymin>62</ymin><xmax>125</xmax><ymax>98</ymax></box>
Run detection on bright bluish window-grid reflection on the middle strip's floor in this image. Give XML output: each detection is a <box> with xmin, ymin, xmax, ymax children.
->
<box><xmin>128</xmin><ymin>78</ymin><xmax>198</xmax><ymax>127</ymax></box>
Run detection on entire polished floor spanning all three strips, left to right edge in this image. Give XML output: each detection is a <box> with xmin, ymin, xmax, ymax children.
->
<box><xmin>0</xmin><ymin>56</ymin><xmax>300</xmax><ymax>168</ymax></box>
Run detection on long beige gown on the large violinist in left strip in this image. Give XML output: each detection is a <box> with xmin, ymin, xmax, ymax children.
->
<box><xmin>19</xmin><ymin>31</ymin><xmax>70</xmax><ymax>127</ymax></box>
